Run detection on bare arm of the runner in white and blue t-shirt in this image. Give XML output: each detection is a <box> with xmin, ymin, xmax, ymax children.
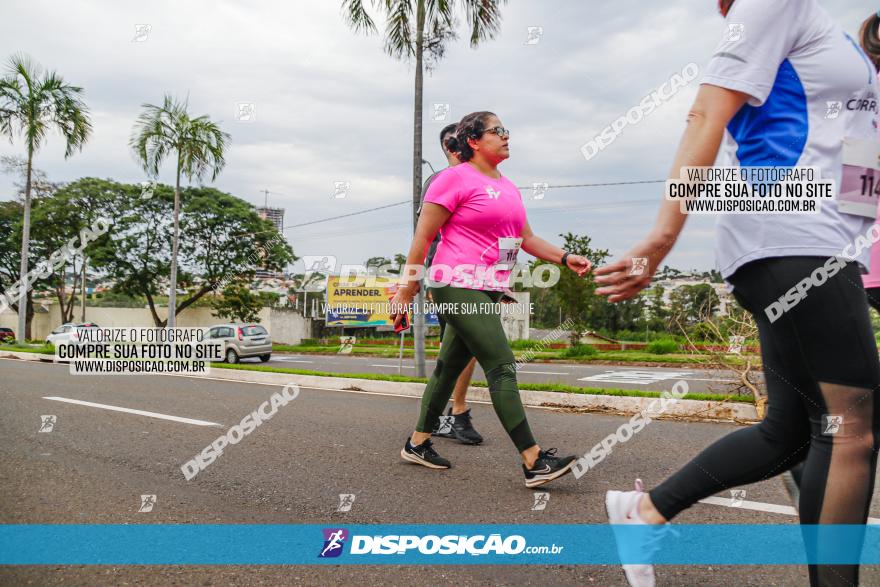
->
<box><xmin>595</xmin><ymin>84</ymin><xmax>750</xmax><ymax>302</ymax></box>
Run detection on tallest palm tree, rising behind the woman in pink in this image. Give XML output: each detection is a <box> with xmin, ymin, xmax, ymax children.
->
<box><xmin>342</xmin><ymin>0</ymin><xmax>507</xmax><ymax>377</ymax></box>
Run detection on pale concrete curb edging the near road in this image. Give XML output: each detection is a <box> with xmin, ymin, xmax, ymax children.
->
<box><xmin>0</xmin><ymin>351</ymin><xmax>759</xmax><ymax>423</ymax></box>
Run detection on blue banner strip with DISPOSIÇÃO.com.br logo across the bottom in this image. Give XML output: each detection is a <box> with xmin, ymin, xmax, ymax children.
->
<box><xmin>0</xmin><ymin>524</ymin><xmax>880</xmax><ymax>565</ymax></box>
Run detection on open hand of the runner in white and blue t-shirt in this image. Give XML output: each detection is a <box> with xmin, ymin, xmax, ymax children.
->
<box><xmin>594</xmin><ymin>233</ymin><xmax>675</xmax><ymax>302</ymax></box>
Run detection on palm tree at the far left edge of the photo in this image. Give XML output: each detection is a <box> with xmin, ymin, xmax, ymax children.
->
<box><xmin>0</xmin><ymin>54</ymin><xmax>92</xmax><ymax>341</ymax></box>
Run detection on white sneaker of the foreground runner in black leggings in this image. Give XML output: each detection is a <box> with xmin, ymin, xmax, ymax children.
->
<box><xmin>605</xmin><ymin>479</ymin><xmax>669</xmax><ymax>587</ymax></box>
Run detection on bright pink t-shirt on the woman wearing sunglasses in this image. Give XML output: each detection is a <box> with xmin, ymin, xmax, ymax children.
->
<box><xmin>425</xmin><ymin>163</ymin><xmax>526</xmax><ymax>291</ymax></box>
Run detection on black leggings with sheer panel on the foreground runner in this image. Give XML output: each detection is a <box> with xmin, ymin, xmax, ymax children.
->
<box><xmin>650</xmin><ymin>257</ymin><xmax>880</xmax><ymax>585</ymax></box>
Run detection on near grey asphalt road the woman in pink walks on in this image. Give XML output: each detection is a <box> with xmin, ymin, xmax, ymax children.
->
<box><xmin>0</xmin><ymin>360</ymin><xmax>880</xmax><ymax>587</ymax></box>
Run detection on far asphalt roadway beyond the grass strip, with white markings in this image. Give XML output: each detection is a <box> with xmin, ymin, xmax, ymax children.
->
<box><xmin>254</xmin><ymin>353</ymin><xmax>762</xmax><ymax>394</ymax></box>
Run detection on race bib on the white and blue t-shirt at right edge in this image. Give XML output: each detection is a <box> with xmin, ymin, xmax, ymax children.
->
<box><xmin>837</xmin><ymin>138</ymin><xmax>880</xmax><ymax>219</ymax></box>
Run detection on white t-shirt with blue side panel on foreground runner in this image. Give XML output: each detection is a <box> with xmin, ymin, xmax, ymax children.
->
<box><xmin>701</xmin><ymin>0</ymin><xmax>878</xmax><ymax>278</ymax></box>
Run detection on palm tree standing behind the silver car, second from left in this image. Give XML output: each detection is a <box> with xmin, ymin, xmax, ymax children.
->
<box><xmin>129</xmin><ymin>94</ymin><xmax>229</xmax><ymax>328</ymax></box>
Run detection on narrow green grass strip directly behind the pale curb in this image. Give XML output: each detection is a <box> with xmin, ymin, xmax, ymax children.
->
<box><xmin>211</xmin><ymin>363</ymin><xmax>754</xmax><ymax>404</ymax></box>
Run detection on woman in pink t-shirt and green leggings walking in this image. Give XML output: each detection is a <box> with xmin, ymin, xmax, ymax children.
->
<box><xmin>392</xmin><ymin>112</ymin><xmax>590</xmax><ymax>487</ymax></box>
